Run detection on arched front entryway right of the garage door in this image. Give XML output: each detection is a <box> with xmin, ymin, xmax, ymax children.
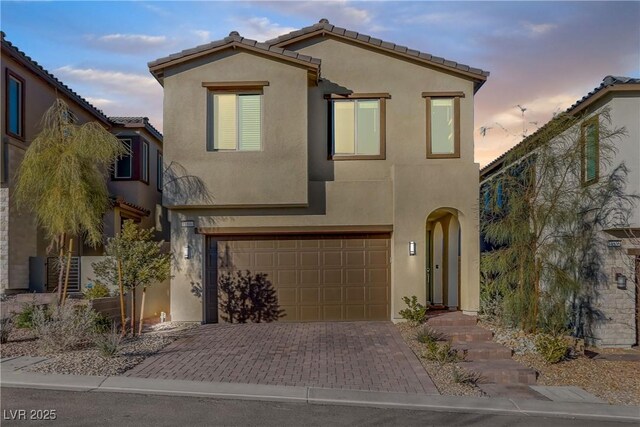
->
<box><xmin>425</xmin><ymin>208</ymin><xmax>462</xmax><ymax>310</ymax></box>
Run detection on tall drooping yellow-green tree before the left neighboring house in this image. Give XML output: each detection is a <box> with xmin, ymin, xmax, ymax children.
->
<box><xmin>16</xmin><ymin>99</ymin><xmax>126</xmax><ymax>302</ymax></box>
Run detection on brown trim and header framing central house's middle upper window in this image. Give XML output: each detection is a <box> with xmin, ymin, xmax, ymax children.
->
<box><xmin>324</xmin><ymin>93</ymin><xmax>384</xmax><ymax>161</ymax></box>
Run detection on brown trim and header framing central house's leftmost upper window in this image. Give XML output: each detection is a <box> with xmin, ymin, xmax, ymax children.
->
<box><xmin>202</xmin><ymin>88</ymin><xmax>269</xmax><ymax>153</ymax></box>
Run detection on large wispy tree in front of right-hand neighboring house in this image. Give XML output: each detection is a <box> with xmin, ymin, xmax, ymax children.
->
<box><xmin>481</xmin><ymin>110</ymin><xmax>635</xmax><ymax>335</ymax></box>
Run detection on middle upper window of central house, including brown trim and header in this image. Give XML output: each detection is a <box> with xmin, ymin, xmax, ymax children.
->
<box><xmin>330</xmin><ymin>94</ymin><xmax>390</xmax><ymax>160</ymax></box>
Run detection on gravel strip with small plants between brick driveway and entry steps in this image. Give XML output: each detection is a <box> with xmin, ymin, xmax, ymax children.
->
<box><xmin>396</xmin><ymin>322</ymin><xmax>484</xmax><ymax>397</ymax></box>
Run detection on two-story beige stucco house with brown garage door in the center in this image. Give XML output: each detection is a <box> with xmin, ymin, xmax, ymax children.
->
<box><xmin>149</xmin><ymin>19</ymin><xmax>489</xmax><ymax>322</ymax></box>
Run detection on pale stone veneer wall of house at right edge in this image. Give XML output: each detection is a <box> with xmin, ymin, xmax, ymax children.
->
<box><xmin>588</xmin><ymin>237</ymin><xmax>637</xmax><ymax>347</ymax></box>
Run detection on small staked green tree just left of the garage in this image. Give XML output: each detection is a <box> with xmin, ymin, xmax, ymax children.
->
<box><xmin>92</xmin><ymin>220</ymin><xmax>171</xmax><ymax>335</ymax></box>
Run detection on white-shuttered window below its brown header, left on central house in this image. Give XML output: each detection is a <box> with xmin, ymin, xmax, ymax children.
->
<box><xmin>207</xmin><ymin>93</ymin><xmax>262</xmax><ymax>151</ymax></box>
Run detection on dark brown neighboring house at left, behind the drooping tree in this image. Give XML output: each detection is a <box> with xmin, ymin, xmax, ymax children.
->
<box><xmin>0</xmin><ymin>33</ymin><xmax>167</xmax><ymax>293</ymax></box>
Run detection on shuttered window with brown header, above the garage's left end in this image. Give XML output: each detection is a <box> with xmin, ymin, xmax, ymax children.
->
<box><xmin>202</xmin><ymin>81</ymin><xmax>269</xmax><ymax>151</ymax></box>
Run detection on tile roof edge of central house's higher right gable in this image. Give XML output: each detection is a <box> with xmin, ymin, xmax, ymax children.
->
<box><xmin>265</xmin><ymin>19</ymin><xmax>489</xmax><ymax>80</ymax></box>
